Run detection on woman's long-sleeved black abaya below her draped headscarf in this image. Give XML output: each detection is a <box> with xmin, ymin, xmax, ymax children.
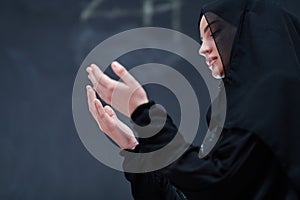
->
<box><xmin>125</xmin><ymin>102</ymin><xmax>299</xmax><ymax>200</ymax></box>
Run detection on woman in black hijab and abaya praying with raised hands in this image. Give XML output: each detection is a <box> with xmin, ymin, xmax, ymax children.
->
<box><xmin>87</xmin><ymin>0</ymin><xmax>300</xmax><ymax>200</ymax></box>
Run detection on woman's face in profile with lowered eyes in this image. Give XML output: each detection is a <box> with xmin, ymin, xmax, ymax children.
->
<box><xmin>199</xmin><ymin>15</ymin><xmax>224</xmax><ymax>79</ymax></box>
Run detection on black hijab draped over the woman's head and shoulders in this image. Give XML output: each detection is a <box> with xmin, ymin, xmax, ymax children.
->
<box><xmin>200</xmin><ymin>0</ymin><xmax>300</xmax><ymax>192</ymax></box>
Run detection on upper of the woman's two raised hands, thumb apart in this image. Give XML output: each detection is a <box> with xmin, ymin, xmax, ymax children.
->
<box><xmin>86</xmin><ymin>62</ymin><xmax>148</xmax><ymax>117</ymax></box>
